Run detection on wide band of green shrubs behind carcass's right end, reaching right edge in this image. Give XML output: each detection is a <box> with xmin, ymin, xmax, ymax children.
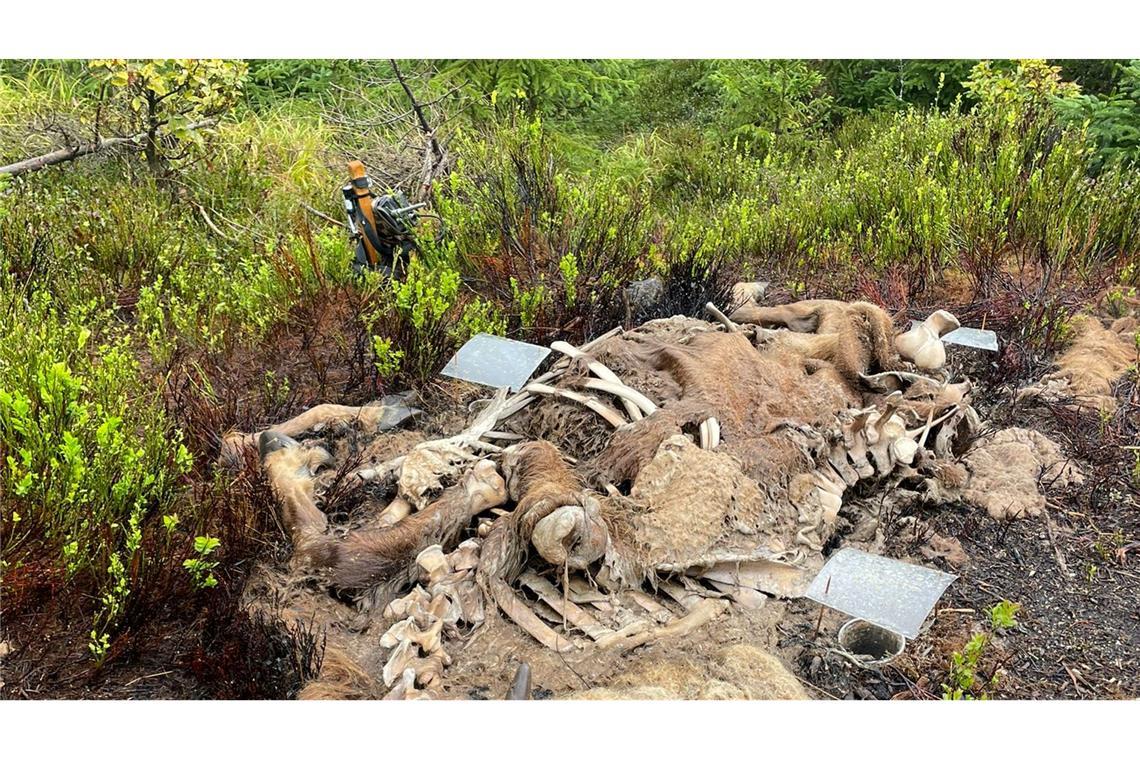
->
<box><xmin>642</xmin><ymin>82</ymin><xmax>1140</xmax><ymax>292</ymax></box>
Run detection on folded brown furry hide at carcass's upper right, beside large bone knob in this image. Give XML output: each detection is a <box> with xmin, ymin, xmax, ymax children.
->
<box><xmin>731</xmin><ymin>299</ymin><xmax>901</xmax><ymax>386</ymax></box>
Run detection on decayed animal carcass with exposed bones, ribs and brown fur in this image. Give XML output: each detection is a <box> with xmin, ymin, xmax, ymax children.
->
<box><xmin>223</xmin><ymin>293</ymin><xmax>994</xmax><ymax>698</ymax></box>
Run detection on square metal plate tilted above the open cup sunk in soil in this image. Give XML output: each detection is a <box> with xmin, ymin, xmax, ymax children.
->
<box><xmin>805</xmin><ymin>548</ymin><xmax>958</xmax><ymax>638</ymax></box>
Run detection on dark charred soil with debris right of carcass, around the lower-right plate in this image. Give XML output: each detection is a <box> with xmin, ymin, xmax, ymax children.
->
<box><xmin>777</xmin><ymin>364</ymin><xmax>1140</xmax><ymax>700</ymax></box>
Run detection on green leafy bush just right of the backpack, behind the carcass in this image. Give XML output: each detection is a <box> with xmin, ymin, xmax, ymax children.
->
<box><xmin>424</xmin><ymin>117</ymin><xmax>652</xmax><ymax>336</ymax></box>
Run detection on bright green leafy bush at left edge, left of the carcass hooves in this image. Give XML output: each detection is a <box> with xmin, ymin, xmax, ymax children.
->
<box><xmin>0</xmin><ymin>281</ymin><xmax>192</xmax><ymax>660</ymax></box>
